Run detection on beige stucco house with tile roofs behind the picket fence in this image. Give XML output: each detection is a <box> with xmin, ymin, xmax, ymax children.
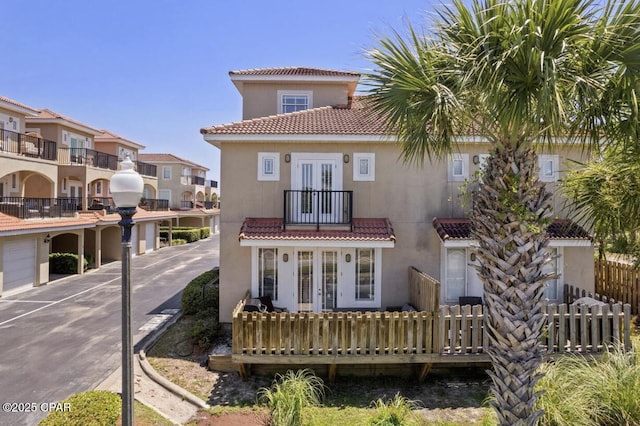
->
<box><xmin>201</xmin><ymin>68</ymin><xmax>594</xmax><ymax>323</ymax></box>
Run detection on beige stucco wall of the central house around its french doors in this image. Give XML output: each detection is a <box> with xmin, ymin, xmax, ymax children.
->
<box><xmin>220</xmin><ymin>141</ymin><xmax>593</xmax><ymax>322</ymax></box>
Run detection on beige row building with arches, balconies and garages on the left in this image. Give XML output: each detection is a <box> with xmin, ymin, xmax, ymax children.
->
<box><xmin>0</xmin><ymin>96</ymin><xmax>175</xmax><ymax>295</ymax></box>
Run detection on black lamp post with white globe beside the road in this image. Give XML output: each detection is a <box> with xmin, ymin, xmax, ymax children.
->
<box><xmin>109</xmin><ymin>156</ymin><xmax>144</xmax><ymax>426</ymax></box>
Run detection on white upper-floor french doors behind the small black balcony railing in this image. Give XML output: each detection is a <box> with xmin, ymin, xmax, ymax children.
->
<box><xmin>291</xmin><ymin>153</ymin><xmax>343</xmax><ymax>223</ymax></box>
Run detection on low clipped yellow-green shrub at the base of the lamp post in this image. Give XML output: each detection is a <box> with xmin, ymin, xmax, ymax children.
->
<box><xmin>40</xmin><ymin>390</ymin><xmax>122</xmax><ymax>426</ymax></box>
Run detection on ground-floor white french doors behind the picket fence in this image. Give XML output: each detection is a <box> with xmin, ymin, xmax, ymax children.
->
<box><xmin>295</xmin><ymin>249</ymin><xmax>339</xmax><ymax>312</ymax></box>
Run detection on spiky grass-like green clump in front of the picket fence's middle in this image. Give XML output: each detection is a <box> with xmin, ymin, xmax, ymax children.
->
<box><xmin>258</xmin><ymin>369</ymin><xmax>325</xmax><ymax>426</ymax></box>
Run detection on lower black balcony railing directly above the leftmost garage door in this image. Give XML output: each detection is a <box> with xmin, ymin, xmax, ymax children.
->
<box><xmin>0</xmin><ymin>197</ymin><xmax>82</xmax><ymax>219</ymax></box>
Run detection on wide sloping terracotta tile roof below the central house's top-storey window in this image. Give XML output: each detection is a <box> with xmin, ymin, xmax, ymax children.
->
<box><xmin>200</xmin><ymin>97</ymin><xmax>386</xmax><ymax>136</ymax></box>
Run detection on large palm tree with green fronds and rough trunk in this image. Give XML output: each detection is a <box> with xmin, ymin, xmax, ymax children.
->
<box><xmin>367</xmin><ymin>0</ymin><xmax>640</xmax><ymax>425</ymax></box>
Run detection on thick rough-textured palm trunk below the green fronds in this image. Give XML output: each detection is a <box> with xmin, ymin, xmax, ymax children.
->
<box><xmin>471</xmin><ymin>143</ymin><xmax>552</xmax><ymax>425</ymax></box>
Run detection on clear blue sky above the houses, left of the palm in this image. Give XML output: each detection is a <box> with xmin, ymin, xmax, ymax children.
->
<box><xmin>0</xmin><ymin>0</ymin><xmax>439</xmax><ymax>186</ymax></box>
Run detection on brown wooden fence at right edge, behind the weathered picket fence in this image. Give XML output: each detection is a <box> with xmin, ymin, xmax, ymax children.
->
<box><xmin>595</xmin><ymin>259</ymin><xmax>640</xmax><ymax>315</ymax></box>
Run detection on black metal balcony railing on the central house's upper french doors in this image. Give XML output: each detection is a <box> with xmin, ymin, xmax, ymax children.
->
<box><xmin>284</xmin><ymin>190</ymin><xmax>353</xmax><ymax>229</ymax></box>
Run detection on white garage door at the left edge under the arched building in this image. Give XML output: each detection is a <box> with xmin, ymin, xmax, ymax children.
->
<box><xmin>2</xmin><ymin>240</ymin><xmax>36</xmax><ymax>292</ymax></box>
